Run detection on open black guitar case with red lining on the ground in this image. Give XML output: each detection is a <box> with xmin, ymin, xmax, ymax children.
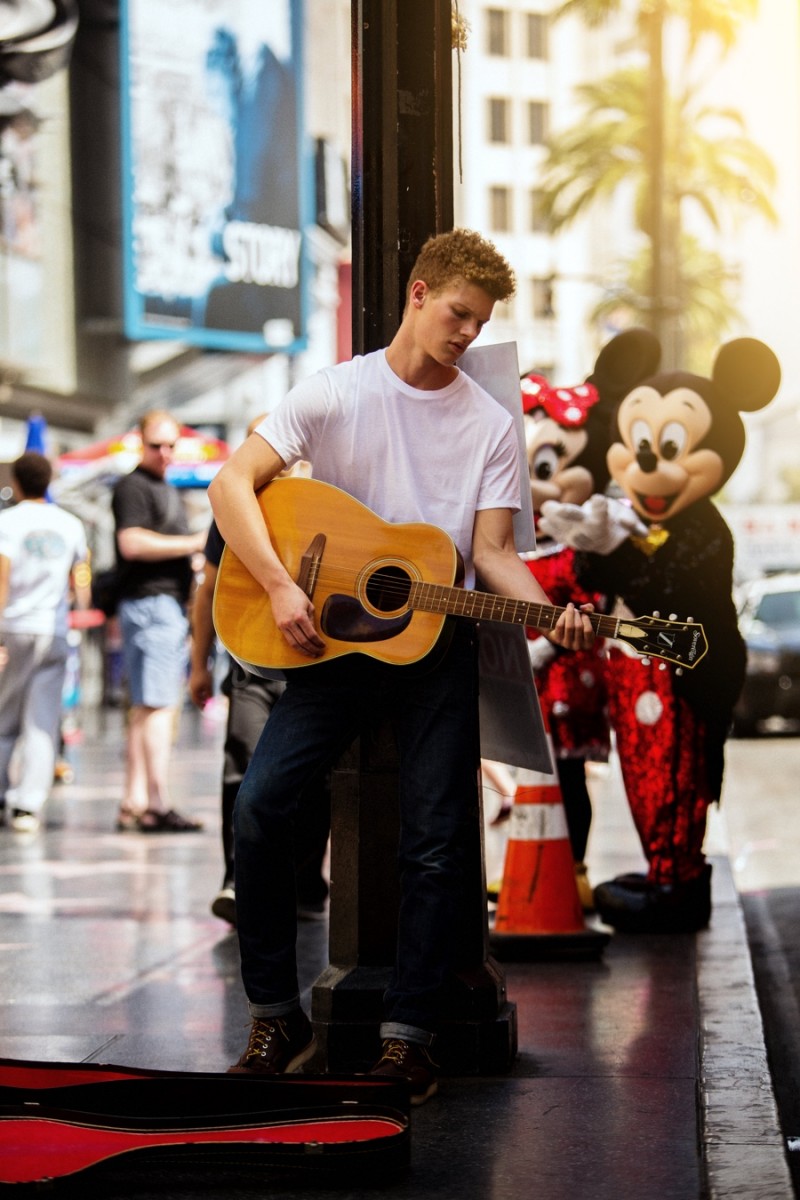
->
<box><xmin>0</xmin><ymin>1058</ymin><xmax>410</xmax><ymax>1195</ymax></box>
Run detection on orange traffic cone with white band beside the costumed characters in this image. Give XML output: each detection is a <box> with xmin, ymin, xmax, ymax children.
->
<box><xmin>489</xmin><ymin>753</ymin><xmax>609</xmax><ymax>959</ymax></box>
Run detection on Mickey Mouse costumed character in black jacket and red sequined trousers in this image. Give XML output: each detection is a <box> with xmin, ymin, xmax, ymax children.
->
<box><xmin>541</xmin><ymin>337</ymin><xmax>781</xmax><ymax>932</ymax></box>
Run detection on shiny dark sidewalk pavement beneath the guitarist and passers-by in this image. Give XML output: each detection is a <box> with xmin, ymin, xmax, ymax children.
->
<box><xmin>0</xmin><ymin>704</ymin><xmax>793</xmax><ymax>1200</ymax></box>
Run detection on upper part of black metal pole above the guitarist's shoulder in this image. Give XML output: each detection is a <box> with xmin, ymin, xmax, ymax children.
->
<box><xmin>353</xmin><ymin>0</ymin><xmax>453</xmax><ymax>354</ymax></box>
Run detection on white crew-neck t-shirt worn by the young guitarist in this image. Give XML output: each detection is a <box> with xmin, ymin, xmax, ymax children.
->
<box><xmin>255</xmin><ymin>350</ymin><xmax>521</xmax><ymax>587</ymax></box>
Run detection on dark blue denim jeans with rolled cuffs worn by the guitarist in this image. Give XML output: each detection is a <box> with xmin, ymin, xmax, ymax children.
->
<box><xmin>235</xmin><ymin>622</ymin><xmax>480</xmax><ymax>1040</ymax></box>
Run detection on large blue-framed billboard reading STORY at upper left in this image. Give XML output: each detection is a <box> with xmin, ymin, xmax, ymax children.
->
<box><xmin>120</xmin><ymin>0</ymin><xmax>312</xmax><ymax>353</ymax></box>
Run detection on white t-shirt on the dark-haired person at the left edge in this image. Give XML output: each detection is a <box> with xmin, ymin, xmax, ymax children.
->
<box><xmin>0</xmin><ymin>500</ymin><xmax>86</xmax><ymax>636</ymax></box>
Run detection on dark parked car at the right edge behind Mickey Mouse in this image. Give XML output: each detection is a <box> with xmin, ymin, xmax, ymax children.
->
<box><xmin>733</xmin><ymin>574</ymin><xmax>800</xmax><ymax>737</ymax></box>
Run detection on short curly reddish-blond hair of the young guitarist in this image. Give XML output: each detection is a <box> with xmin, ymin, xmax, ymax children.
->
<box><xmin>405</xmin><ymin>229</ymin><xmax>517</xmax><ymax>301</ymax></box>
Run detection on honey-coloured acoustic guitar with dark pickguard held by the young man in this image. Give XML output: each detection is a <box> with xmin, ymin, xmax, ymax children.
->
<box><xmin>213</xmin><ymin>476</ymin><xmax>708</xmax><ymax>674</ymax></box>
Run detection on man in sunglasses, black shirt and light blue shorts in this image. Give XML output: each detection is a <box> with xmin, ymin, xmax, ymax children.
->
<box><xmin>112</xmin><ymin>412</ymin><xmax>205</xmax><ymax>833</ymax></box>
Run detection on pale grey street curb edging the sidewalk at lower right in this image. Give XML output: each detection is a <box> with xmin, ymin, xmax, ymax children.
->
<box><xmin>697</xmin><ymin>857</ymin><xmax>794</xmax><ymax>1200</ymax></box>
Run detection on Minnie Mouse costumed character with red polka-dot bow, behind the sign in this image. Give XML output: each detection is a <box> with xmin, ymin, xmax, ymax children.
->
<box><xmin>522</xmin><ymin>329</ymin><xmax>660</xmax><ymax>911</ymax></box>
